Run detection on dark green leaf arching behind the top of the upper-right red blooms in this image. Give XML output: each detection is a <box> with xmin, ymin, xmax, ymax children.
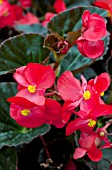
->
<box><xmin>47</xmin><ymin>6</ymin><xmax>107</xmax><ymax>36</ymax></box>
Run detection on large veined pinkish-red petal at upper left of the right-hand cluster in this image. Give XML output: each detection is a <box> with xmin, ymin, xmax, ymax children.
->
<box><xmin>57</xmin><ymin>71</ymin><xmax>83</xmax><ymax>102</ymax></box>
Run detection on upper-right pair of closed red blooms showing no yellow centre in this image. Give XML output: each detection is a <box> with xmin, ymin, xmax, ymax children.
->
<box><xmin>76</xmin><ymin>10</ymin><xmax>107</xmax><ymax>59</ymax></box>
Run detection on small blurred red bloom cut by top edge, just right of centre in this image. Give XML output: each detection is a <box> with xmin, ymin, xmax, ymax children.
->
<box><xmin>53</xmin><ymin>0</ymin><xmax>66</xmax><ymax>13</ymax></box>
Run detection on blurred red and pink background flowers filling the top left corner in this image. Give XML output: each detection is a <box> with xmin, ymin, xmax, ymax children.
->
<box><xmin>0</xmin><ymin>0</ymin><xmax>39</xmax><ymax>28</ymax></box>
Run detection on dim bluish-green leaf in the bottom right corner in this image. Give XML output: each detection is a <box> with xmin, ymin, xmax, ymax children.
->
<box><xmin>86</xmin><ymin>149</ymin><xmax>112</xmax><ymax>170</ymax></box>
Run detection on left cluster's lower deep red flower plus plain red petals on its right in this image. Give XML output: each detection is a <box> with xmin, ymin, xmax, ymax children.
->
<box><xmin>7</xmin><ymin>96</ymin><xmax>65</xmax><ymax>128</ymax></box>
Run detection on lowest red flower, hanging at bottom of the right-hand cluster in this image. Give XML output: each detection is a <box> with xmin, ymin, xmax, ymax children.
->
<box><xmin>73</xmin><ymin>132</ymin><xmax>112</xmax><ymax>162</ymax></box>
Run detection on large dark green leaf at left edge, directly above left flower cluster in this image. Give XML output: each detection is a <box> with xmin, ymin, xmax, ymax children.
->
<box><xmin>0</xmin><ymin>34</ymin><xmax>49</xmax><ymax>74</ymax></box>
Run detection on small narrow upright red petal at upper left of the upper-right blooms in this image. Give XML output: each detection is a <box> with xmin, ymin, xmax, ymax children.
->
<box><xmin>82</xmin><ymin>10</ymin><xmax>91</xmax><ymax>27</ymax></box>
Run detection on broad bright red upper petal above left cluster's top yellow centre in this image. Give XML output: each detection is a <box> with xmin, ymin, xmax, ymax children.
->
<box><xmin>25</xmin><ymin>63</ymin><xmax>55</xmax><ymax>89</ymax></box>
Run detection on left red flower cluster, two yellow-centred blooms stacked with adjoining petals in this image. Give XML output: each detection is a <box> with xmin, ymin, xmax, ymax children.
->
<box><xmin>8</xmin><ymin>63</ymin><xmax>69</xmax><ymax>128</ymax></box>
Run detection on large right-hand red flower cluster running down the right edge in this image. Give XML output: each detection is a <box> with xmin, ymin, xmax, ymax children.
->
<box><xmin>57</xmin><ymin>71</ymin><xmax>112</xmax><ymax>162</ymax></box>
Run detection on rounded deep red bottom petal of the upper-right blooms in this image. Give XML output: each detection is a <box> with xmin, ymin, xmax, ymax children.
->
<box><xmin>83</xmin><ymin>40</ymin><xmax>104</xmax><ymax>59</ymax></box>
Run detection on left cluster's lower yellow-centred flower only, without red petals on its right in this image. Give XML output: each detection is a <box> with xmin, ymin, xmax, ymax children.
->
<box><xmin>8</xmin><ymin>97</ymin><xmax>46</xmax><ymax>128</ymax></box>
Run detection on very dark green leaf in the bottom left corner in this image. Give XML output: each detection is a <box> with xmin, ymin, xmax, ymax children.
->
<box><xmin>0</xmin><ymin>148</ymin><xmax>17</xmax><ymax>170</ymax></box>
